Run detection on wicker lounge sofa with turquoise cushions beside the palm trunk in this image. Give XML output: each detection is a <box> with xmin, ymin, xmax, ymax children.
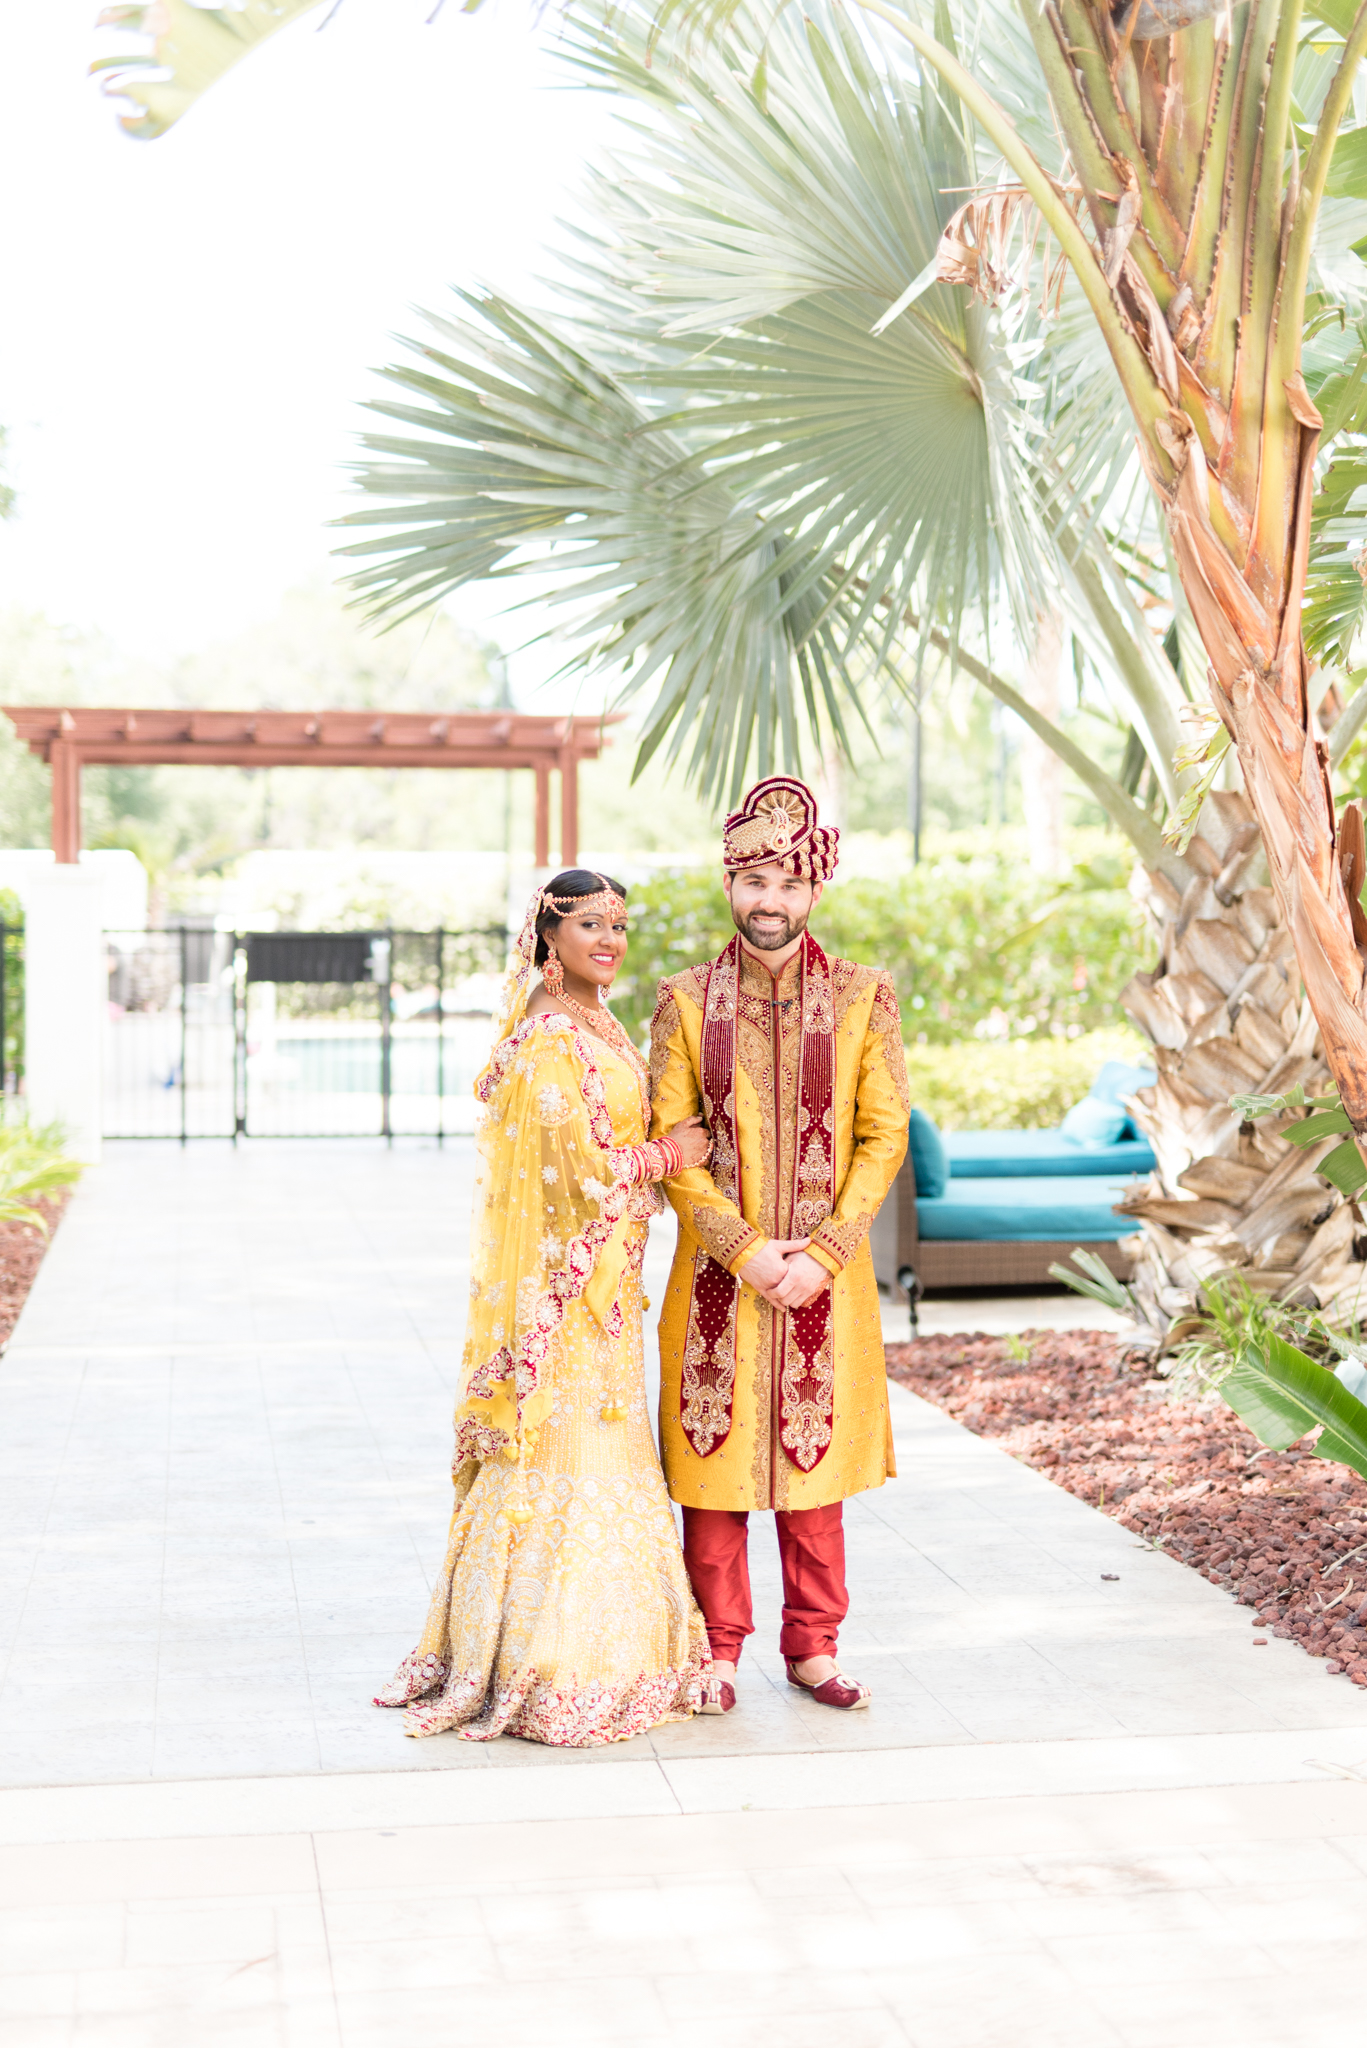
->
<box><xmin>873</xmin><ymin>1061</ymin><xmax>1156</xmax><ymax>1327</ymax></box>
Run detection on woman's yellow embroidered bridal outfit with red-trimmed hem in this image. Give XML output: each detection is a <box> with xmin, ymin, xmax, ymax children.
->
<box><xmin>379</xmin><ymin>1018</ymin><xmax>707</xmax><ymax>1747</ymax></box>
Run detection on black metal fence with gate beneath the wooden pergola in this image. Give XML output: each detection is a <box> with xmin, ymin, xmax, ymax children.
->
<box><xmin>105</xmin><ymin>926</ymin><xmax>506</xmax><ymax>1143</ymax></box>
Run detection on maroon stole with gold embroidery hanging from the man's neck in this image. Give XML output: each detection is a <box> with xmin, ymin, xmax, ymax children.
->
<box><xmin>680</xmin><ymin>932</ymin><xmax>836</xmax><ymax>1473</ymax></box>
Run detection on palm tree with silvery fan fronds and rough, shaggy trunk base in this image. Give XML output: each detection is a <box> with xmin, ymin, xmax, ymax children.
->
<box><xmin>98</xmin><ymin>10</ymin><xmax>1363</xmax><ymax>1333</ymax></box>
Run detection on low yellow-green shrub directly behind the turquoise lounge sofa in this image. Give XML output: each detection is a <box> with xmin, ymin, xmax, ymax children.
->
<box><xmin>906</xmin><ymin>1030</ymin><xmax>1148</xmax><ymax>1130</ymax></box>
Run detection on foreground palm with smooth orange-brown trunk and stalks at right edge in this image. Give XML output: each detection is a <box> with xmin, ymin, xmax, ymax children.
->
<box><xmin>786</xmin><ymin>0</ymin><xmax>1367</xmax><ymax>1138</ymax></box>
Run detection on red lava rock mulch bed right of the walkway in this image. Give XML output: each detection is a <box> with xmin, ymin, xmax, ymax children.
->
<box><xmin>887</xmin><ymin>1329</ymin><xmax>1367</xmax><ymax>1686</ymax></box>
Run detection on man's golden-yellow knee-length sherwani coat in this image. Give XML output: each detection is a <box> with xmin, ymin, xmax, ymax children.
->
<box><xmin>652</xmin><ymin>948</ymin><xmax>908</xmax><ymax>1509</ymax></box>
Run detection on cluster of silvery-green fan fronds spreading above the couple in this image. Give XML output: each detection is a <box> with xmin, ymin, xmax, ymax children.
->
<box><xmin>344</xmin><ymin>6</ymin><xmax>1114</xmax><ymax>795</ymax></box>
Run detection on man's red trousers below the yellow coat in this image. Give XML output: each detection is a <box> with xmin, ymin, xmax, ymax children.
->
<box><xmin>685</xmin><ymin>1501</ymin><xmax>851</xmax><ymax>1663</ymax></box>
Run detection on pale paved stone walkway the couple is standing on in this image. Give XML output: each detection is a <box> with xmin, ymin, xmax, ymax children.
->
<box><xmin>0</xmin><ymin>1141</ymin><xmax>1367</xmax><ymax>2048</ymax></box>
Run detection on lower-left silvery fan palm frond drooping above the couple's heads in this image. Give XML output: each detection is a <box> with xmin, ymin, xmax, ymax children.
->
<box><xmin>344</xmin><ymin>295</ymin><xmax>864</xmax><ymax>788</ymax></box>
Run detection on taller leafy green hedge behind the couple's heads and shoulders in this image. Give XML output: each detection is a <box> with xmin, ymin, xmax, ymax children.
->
<box><xmin>613</xmin><ymin>850</ymin><xmax>1150</xmax><ymax>1048</ymax></box>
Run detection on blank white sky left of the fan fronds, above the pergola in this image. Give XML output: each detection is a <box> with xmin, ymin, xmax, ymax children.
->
<box><xmin>0</xmin><ymin>0</ymin><xmax>607</xmax><ymax>696</ymax></box>
